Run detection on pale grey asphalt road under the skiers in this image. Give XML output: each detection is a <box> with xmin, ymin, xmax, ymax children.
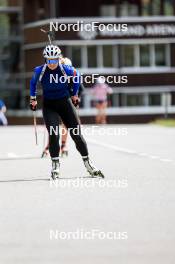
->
<box><xmin>0</xmin><ymin>125</ymin><xmax>175</xmax><ymax>264</ymax></box>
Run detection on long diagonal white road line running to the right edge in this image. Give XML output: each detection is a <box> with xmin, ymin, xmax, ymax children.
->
<box><xmin>87</xmin><ymin>139</ymin><xmax>175</xmax><ymax>163</ymax></box>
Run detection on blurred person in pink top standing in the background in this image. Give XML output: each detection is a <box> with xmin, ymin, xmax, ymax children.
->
<box><xmin>92</xmin><ymin>77</ymin><xmax>113</xmax><ymax>124</ymax></box>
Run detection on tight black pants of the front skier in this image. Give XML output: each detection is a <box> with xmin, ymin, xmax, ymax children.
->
<box><xmin>43</xmin><ymin>97</ymin><xmax>88</xmax><ymax>158</ymax></box>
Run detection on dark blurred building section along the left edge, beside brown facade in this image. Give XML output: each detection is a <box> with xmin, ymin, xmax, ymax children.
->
<box><xmin>0</xmin><ymin>0</ymin><xmax>24</xmax><ymax>109</ymax></box>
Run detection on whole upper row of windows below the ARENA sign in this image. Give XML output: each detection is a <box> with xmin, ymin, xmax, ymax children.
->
<box><xmin>68</xmin><ymin>44</ymin><xmax>170</xmax><ymax>70</ymax></box>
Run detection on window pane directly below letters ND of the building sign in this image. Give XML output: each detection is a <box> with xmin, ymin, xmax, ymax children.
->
<box><xmin>121</xmin><ymin>45</ymin><xmax>134</xmax><ymax>67</ymax></box>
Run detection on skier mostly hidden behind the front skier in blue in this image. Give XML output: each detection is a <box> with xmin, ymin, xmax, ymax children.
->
<box><xmin>41</xmin><ymin>55</ymin><xmax>85</xmax><ymax>158</ymax></box>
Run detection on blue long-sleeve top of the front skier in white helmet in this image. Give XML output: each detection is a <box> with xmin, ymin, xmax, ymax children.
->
<box><xmin>30</xmin><ymin>64</ymin><xmax>80</xmax><ymax>100</ymax></box>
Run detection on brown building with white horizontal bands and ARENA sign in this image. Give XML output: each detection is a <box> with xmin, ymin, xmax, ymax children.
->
<box><xmin>1</xmin><ymin>0</ymin><xmax>175</xmax><ymax>122</ymax></box>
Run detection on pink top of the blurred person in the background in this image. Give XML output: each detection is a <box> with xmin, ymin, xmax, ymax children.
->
<box><xmin>92</xmin><ymin>83</ymin><xmax>113</xmax><ymax>101</ymax></box>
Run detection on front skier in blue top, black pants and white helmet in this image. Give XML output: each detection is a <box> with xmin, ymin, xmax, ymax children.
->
<box><xmin>30</xmin><ymin>45</ymin><xmax>104</xmax><ymax>180</ymax></box>
